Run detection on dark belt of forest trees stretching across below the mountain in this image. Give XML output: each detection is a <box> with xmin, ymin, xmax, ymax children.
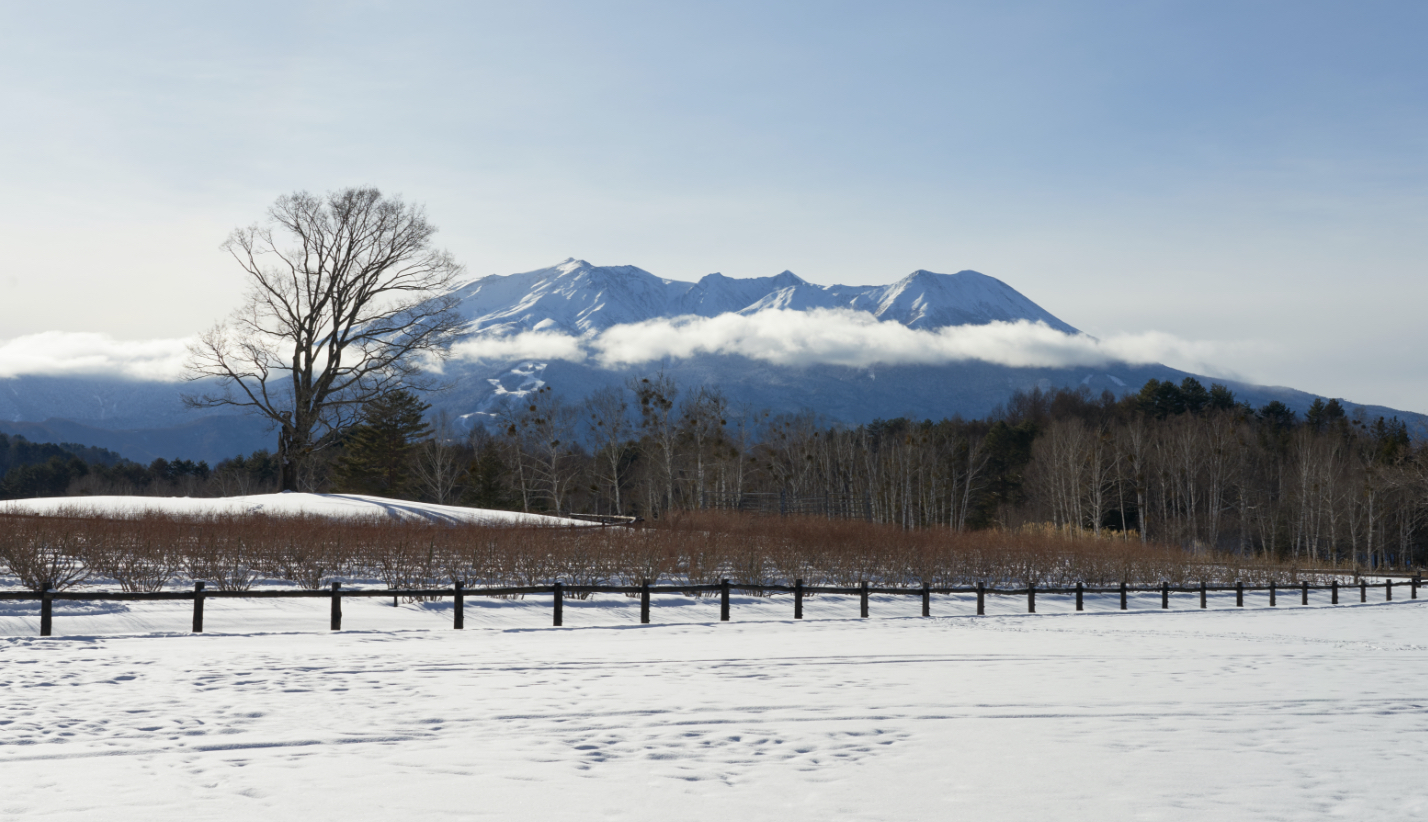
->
<box><xmin>8</xmin><ymin>375</ymin><xmax>1428</xmax><ymax>567</ymax></box>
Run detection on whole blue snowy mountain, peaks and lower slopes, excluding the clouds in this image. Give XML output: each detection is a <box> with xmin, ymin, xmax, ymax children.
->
<box><xmin>0</xmin><ymin>260</ymin><xmax>1428</xmax><ymax>462</ymax></box>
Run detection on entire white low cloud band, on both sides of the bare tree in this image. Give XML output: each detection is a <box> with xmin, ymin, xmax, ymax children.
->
<box><xmin>0</xmin><ymin>308</ymin><xmax>1215</xmax><ymax>381</ymax></box>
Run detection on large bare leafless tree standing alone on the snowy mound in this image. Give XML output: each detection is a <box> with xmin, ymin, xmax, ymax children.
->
<box><xmin>184</xmin><ymin>188</ymin><xmax>461</xmax><ymax>491</ymax></box>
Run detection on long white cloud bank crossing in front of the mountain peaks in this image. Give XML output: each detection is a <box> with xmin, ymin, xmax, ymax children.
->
<box><xmin>454</xmin><ymin>308</ymin><xmax>1212</xmax><ymax>368</ymax></box>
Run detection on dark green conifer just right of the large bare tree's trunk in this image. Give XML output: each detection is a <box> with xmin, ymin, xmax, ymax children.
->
<box><xmin>334</xmin><ymin>391</ymin><xmax>431</xmax><ymax>499</ymax></box>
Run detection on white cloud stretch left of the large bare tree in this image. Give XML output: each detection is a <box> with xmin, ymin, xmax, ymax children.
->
<box><xmin>0</xmin><ymin>331</ymin><xmax>190</xmax><ymax>381</ymax></box>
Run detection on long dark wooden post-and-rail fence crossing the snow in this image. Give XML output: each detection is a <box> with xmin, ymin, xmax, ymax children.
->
<box><xmin>0</xmin><ymin>575</ymin><xmax>1422</xmax><ymax>636</ymax></box>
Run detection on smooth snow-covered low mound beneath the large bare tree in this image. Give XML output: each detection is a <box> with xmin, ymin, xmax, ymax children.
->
<box><xmin>0</xmin><ymin>492</ymin><xmax>590</xmax><ymax>525</ymax></box>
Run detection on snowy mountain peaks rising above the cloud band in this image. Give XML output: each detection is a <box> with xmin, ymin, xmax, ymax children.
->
<box><xmin>457</xmin><ymin>260</ymin><xmax>1077</xmax><ymax>334</ymax></box>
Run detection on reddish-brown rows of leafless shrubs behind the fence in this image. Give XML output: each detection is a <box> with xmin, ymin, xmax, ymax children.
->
<box><xmin>0</xmin><ymin>512</ymin><xmax>1359</xmax><ymax>591</ymax></box>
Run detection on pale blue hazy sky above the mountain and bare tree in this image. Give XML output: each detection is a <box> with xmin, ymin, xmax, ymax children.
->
<box><xmin>0</xmin><ymin>0</ymin><xmax>1428</xmax><ymax>411</ymax></box>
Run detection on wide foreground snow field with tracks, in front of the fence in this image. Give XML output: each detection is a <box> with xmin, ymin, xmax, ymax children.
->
<box><xmin>0</xmin><ymin>595</ymin><xmax>1428</xmax><ymax>822</ymax></box>
